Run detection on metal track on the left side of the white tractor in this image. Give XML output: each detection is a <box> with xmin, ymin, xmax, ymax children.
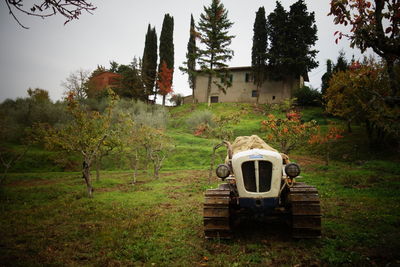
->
<box><xmin>203</xmin><ymin>188</ymin><xmax>232</xmax><ymax>239</ymax></box>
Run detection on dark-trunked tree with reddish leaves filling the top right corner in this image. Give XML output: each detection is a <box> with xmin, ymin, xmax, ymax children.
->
<box><xmin>329</xmin><ymin>0</ymin><xmax>400</xmax><ymax>96</ymax></box>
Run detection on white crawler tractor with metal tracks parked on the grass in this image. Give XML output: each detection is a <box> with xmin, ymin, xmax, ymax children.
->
<box><xmin>204</xmin><ymin>135</ymin><xmax>321</xmax><ymax>239</ymax></box>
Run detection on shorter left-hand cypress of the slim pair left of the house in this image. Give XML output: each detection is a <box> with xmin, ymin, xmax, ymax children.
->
<box><xmin>142</xmin><ymin>24</ymin><xmax>158</xmax><ymax>101</ymax></box>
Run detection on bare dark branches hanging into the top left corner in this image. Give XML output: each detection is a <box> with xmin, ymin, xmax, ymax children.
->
<box><xmin>4</xmin><ymin>0</ymin><xmax>96</xmax><ymax>29</ymax></box>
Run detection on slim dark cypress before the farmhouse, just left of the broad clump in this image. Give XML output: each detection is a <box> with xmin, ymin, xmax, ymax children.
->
<box><xmin>251</xmin><ymin>7</ymin><xmax>268</xmax><ymax>103</ymax></box>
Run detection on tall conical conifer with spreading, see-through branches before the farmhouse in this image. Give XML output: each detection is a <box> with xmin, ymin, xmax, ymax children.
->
<box><xmin>197</xmin><ymin>0</ymin><xmax>234</xmax><ymax>106</ymax></box>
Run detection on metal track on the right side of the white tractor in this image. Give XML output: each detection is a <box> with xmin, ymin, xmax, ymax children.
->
<box><xmin>289</xmin><ymin>183</ymin><xmax>321</xmax><ymax>238</ymax></box>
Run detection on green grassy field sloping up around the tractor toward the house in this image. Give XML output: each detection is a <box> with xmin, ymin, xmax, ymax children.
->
<box><xmin>0</xmin><ymin>104</ymin><xmax>400</xmax><ymax>266</ymax></box>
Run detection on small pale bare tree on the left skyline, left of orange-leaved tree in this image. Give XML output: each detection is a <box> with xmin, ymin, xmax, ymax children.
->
<box><xmin>61</xmin><ymin>69</ymin><xmax>90</xmax><ymax>100</ymax></box>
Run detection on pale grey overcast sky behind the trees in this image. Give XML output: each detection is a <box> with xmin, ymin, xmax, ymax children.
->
<box><xmin>0</xmin><ymin>0</ymin><xmax>376</xmax><ymax>101</ymax></box>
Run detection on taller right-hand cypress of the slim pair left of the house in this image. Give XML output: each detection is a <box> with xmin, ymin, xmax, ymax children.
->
<box><xmin>158</xmin><ymin>14</ymin><xmax>174</xmax><ymax>105</ymax></box>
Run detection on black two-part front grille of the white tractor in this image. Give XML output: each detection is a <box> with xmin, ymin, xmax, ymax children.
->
<box><xmin>242</xmin><ymin>160</ymin><xmax>272</xmax><ymax>193</ymax></box>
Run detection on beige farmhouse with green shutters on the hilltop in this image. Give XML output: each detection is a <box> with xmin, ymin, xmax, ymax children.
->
<box><xmin>184</xmin><ymin>67</ymin><xmax>308</xmax><ymax>104</ymax></box>
